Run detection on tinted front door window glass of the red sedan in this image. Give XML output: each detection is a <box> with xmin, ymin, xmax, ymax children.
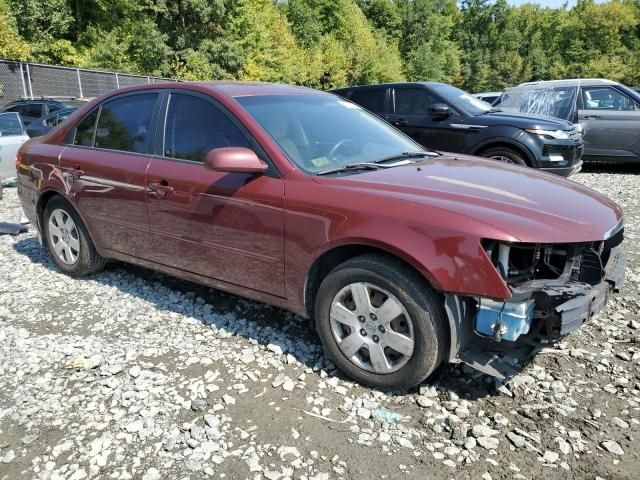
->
<box><xmin>164</xmin><ymin>93</ymin><xmax>252</xmax><ymax>162</ymax></box>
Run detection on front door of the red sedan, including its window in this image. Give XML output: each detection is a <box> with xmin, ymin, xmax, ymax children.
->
<box><xmin>147</xmin><ymin>92</ymin><xmax>284</xmax><ymax>296</ymax></box>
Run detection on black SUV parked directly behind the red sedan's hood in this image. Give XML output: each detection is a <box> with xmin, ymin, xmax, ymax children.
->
<box><xmin>332</xmin><ymin>82</ymin><xmax>583</xmax><ymax>177</ymax></box>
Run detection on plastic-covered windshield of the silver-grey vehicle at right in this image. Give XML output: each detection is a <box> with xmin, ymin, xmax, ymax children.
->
<box><xmin>498</xmin><ymin>86</ymin><xmax>578</xmax><ymax>121</ymax></box>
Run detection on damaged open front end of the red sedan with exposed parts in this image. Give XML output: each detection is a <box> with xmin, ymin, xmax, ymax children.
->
<box><xmin>445</xmin><ymin>220</ymin><xmax>626</xmax><ymax>379</ymax></box>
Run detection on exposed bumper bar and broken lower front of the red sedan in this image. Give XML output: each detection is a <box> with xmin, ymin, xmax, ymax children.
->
<box><xmin>445</xmin><ymin>246</ymin><xmax>627</xmax><ymax>380</ymax></box>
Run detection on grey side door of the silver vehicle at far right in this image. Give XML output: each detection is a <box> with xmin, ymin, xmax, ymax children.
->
<box><xmin>578</xmin><ymin>86</ymin><xmax>640</xmax><ymax>161</ymax></box>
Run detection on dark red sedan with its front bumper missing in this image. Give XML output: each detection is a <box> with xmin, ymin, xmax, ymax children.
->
<box><xmin>16</xmin><ymin>83</ymin><xmax>625</xmax><ymax>389</ymax></box>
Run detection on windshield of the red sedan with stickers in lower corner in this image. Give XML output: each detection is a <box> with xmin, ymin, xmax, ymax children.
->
<box><xmin>236</xmin><ymin>94</ymin><xmax>424</xmax><ymax>174</ymax></box>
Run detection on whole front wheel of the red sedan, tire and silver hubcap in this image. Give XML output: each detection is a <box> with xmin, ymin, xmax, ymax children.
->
<box><xmin>315</xmin><ymin>254</ymin><xmax>445</xmax><ymax>390</ymax></box>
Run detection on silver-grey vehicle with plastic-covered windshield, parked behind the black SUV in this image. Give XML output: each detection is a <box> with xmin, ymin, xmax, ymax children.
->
<box><xmin>496</xmin><ymin>79</ymin><xmax>640</xmax><ymax>163</ymax></box>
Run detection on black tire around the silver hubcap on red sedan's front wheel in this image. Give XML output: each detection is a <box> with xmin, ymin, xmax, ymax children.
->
<box><xmin>315</xmin><ymin>254</ymin><xmax>447</xmax><ymax>390</ymax></box>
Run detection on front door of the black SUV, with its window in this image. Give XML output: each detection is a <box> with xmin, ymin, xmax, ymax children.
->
<box><xmin>389</xmin><ymin>87</ymin><xmax>465</xmax><ymax>152</ymax></box>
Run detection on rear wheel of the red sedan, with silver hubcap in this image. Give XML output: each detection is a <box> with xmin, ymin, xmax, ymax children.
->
<box><xmin>42</xmin><ymin>197</ymin><xmax>106</xmax><ymax>276</ymax></box>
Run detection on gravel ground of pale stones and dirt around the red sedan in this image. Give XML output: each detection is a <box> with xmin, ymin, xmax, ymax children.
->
<box><xmin>0</xmin><ymin>169</ymin><xmax>640</xmax><ymax>480</ymax></box>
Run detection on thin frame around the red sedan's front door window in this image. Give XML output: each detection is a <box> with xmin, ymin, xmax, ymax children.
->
<box><xmin>152</xmin><ymin>88</ymin><xmax>282</xmax><ymax>178</ymax></box>
